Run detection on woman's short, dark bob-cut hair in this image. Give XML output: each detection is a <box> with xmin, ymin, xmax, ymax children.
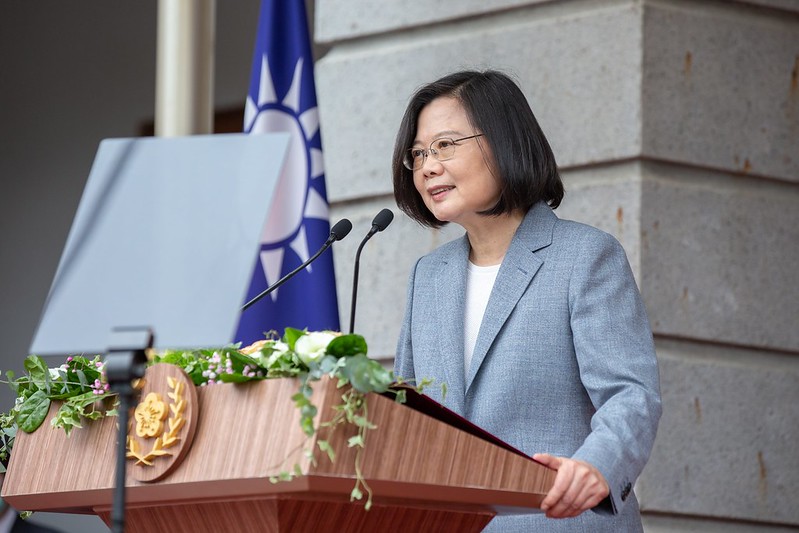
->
<box><xmin>392</xmin><ymin>70</ymin><xmax>563</xmax><ymax>228</ymax></box>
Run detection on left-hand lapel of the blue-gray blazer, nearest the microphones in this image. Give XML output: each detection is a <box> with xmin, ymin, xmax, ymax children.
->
<box><xmin>433</xmin><ymin>236</ymin><xmax>469</xmax><ymax>414</ymax></box>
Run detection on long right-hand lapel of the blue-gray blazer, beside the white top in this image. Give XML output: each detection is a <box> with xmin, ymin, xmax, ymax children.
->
<box><xmin>468</xmin><ymin>202</ymin><xmax>557</xmax><ymax>394</ymax></box>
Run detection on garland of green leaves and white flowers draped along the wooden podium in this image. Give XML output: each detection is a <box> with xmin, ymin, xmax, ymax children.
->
<box><xmin>0</xmin><ymin>328</ymin><xmax>438</xmax><ymax>509</ymax></box>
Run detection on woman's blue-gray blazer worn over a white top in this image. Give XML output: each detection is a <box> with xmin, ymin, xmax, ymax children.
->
<box><xmin>395</xmin><ymin>203</ymin><xmax>661</xmax><ymax>533</ymax></box>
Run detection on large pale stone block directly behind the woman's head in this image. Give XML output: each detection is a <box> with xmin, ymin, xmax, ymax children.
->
<box><xmin>316</xmin><ymin>4</ymin><xmax>642</xmax><ymax>201</ymax></box>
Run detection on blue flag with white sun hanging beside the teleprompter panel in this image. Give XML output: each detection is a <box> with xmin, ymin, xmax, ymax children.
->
<box><xmin>234</xmin><ymin>0</ymin><xmax>339</xmax><ymax>344</ymax></box>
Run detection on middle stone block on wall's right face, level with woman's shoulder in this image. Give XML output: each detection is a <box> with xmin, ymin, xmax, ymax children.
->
<box><xmin>641</xmin><ymin>163</ymin><xmax>799</xmax><ymax>352</ymax></box>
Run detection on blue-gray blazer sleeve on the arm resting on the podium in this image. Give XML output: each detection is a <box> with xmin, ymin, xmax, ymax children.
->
<box><xmin>569</xmin><ymin>231</ymin><xmax>661</xmax><ymax>513</ymax></box>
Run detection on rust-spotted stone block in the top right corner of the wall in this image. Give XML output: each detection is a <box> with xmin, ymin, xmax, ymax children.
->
<box><xmin>642</xmin><ymin>2</ymin><xmax>799</xmax><ymax>181</ymax></box>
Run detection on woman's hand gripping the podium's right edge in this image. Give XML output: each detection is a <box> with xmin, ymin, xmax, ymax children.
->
<box><xmin>533</xmin><ymin>453</ymin><xmax>610</xmax><ymax>518</ymax></box>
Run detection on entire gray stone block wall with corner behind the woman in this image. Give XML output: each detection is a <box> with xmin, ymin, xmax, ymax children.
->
<box><xmin>316</xmin><ymin>0</ymin><xmax>799</xmax><ymax>532</ymax></box>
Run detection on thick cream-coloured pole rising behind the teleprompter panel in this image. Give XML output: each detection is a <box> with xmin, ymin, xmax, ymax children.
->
<box><xmin>155</xmin><ymin>0</ymin><xmax>216</xmax><ymax>137</ymax></box>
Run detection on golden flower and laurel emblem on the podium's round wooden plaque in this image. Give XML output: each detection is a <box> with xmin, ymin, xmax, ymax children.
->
<box><xmin>126</xmin><ymin>376</ymin><xmax>187</xmax><ymax>466</ymax></box>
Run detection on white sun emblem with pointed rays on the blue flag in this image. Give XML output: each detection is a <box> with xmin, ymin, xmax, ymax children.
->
<box><xmin>244</xmin><ymin>55</ymin><xmax>329</xmax><ymax>301</ymax></box>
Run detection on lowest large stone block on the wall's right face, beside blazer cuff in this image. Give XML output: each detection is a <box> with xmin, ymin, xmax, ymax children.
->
<box><xmin>636</xmin><ymin>341</ymin><xmax>799</xmax><ymax>531</ymax></box>
